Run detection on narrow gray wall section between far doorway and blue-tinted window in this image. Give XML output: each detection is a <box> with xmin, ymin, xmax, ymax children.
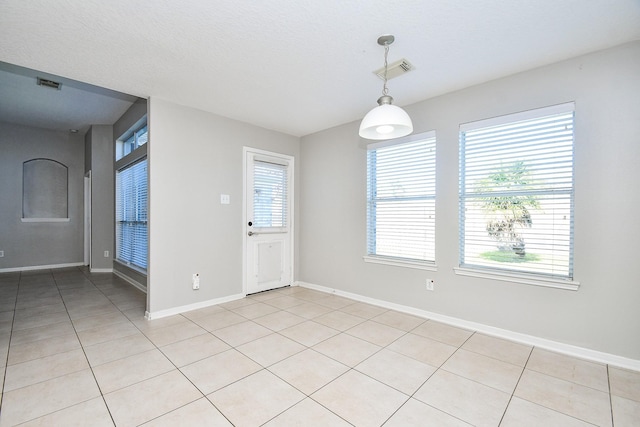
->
<box><xmin>85</xmin><ymin>125</ymin><xmax>115</xmax><ymax>271</ymax></box>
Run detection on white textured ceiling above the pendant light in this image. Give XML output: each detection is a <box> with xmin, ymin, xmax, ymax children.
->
<box><xmin>0</xmin><ymin>0</ymin><xmax>640</xmax><ymax>136</ymax></box>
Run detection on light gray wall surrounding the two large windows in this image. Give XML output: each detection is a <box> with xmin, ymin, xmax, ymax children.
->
<box><xmin>298</xmin><ymin>42</ymin><xmax>640</xmax><ymax>360</ymax></box>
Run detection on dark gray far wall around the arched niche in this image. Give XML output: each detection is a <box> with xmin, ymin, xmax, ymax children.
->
<box><xmin>0</xmin><ymin>122</ymin><xmax>84</xmax><ymax>269</ymax></box>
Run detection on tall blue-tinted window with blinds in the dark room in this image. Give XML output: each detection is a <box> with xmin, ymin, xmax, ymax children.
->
<box><xmin>116</xmin><ymin>158</ymin><xmax>148</xmax><ymax>270</ymax></box>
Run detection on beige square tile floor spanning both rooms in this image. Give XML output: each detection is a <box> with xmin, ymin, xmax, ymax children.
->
<box><xmin>0</xmin><ymin>268</ymin><xmax>640</xmax><ymax>427</ymax></box>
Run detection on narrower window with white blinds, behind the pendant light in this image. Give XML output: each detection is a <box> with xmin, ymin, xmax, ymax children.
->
<box><xmin>367</xmin><ymin>132</ymin><xmax>436</xmax><ymax>262</ymax></box>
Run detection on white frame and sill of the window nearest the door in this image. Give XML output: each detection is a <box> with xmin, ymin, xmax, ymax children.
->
<box><xmin>363</xmin><ymin>130</ymin><xmax>437</xmax><ymax>271</ymax></box>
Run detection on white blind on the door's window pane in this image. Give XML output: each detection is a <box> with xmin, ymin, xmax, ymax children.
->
<box><xmin>253</xmin><ymin>159</ymin><xmax>288</xmax><ymax>228</ymax></box>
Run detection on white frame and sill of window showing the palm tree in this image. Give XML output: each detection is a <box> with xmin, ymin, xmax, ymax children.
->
<box><xmin>454</xmin><ymin>102</ymin><xmax>580</xmax><ymax>290</ymax></box>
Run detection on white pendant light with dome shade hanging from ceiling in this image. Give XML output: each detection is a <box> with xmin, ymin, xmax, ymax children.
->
<box><xmin>359</xmin><ymin>34</ymin><xmax>413</xmax><ymax>139</ymax></box>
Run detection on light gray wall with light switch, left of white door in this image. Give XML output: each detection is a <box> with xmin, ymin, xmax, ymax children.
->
<box><xmin>147</xmin><ymin>97</ymin><xmax>300</xmax><ymax>314</ymax></box>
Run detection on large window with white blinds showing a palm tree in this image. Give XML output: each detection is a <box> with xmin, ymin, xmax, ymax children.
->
<box><xmin>460</xmin><ymin>103</ymin><xmax>574</xmax><ymax>279</ymax></box>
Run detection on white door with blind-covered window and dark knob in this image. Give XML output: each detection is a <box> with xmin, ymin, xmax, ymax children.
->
<box><xmin>244</xmin><ymin>148</ymin><xmax>293</xmax><ymax>294</ymax></box>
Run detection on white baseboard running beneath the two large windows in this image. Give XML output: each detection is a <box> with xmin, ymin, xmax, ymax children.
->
<box><xmin>296</xmin><ymin>281</ymin><xmax>640</xmax><ymax>371</ymax></box>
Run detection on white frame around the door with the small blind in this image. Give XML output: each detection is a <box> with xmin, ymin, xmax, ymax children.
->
<box><xmin>241</xmin><ymin>146</ymin><xmax>295</xmax><ymax>295</ymax></box>
